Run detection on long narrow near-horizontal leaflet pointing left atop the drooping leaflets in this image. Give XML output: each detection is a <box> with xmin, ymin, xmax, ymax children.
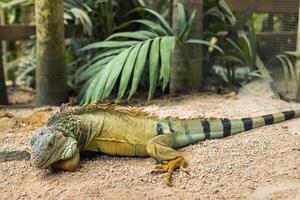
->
<box><xmin>79</xmin><ymin>41</ymin><xmax>137</xmax><ymax>51</ymax></box>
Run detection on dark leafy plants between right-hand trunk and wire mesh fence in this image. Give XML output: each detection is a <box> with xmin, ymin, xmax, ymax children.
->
<box><xmin>204</xmin><ymin>0</ymin><xmax>261</xmax><ymax>91</ymax></box>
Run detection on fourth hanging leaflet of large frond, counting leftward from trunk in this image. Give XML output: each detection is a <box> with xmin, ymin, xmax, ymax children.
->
<box><xmin>117</xmin><ymin>43</ymin><xmax>142</xmax><ymax>101</ymax></box>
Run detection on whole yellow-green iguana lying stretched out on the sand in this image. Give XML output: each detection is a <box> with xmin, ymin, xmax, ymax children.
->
<box><xmin>30</xmin><ymin>104</ymin><xmax>300</xmax><ymax>185</ymax></box>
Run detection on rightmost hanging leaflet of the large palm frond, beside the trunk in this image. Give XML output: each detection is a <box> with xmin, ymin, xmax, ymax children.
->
<box><xmin>159</xmin><ymin>37</ymin><xmax>176</xmax><ymax>91</ymax></box>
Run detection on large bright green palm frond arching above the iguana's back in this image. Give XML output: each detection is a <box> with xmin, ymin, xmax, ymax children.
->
<box><xmin>77</xmin><ymin>4</ymin><xmax>222</xmax><ymax>104</ymax></box>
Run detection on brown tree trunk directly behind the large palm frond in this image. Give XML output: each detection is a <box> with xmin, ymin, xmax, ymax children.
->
<box><xmin>170</xmin><ymin>0</ymin><xmax>203</xmax><ymax>94</ymax></box>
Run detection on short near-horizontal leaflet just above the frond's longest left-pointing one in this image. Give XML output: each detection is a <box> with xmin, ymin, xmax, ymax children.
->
<box><xmin>106</xmin><ymin>31</ymin><xmax>157</xmax><ymax>40</ymax></box>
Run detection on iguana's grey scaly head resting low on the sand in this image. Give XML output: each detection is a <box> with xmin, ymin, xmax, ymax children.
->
<box><xmin>30</xmin><ymin>127</ymin><xmax>77</xmax><ymax>169</ymax></box>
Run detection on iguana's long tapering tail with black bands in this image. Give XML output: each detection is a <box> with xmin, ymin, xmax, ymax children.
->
<box><xmin>163</xmin><ymin>110</ymin><xmax>300</xmax><ymax>148</ymax></box>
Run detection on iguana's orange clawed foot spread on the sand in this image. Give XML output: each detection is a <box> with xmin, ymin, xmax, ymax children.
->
<box><xmin>154</xmin><ymin>156</ymin><xmax>188</xmax><ymax>186</ymax></box>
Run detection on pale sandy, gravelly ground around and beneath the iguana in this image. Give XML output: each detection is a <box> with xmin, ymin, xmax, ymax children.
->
<box><xmin>0</xmin><ymin>94</ymin><xmax>300</xmax><ymax>200</ymax></box>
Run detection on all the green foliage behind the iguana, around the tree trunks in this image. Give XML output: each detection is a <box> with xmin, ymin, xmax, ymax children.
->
<box><xmin>1</xmin><ymin>0</ymin><xmax>266</xmax><ymax>103</ymax></box>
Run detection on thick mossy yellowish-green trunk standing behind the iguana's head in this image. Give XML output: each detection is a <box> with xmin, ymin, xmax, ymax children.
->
<box><xmin>35</xmin><ymin>0</ymin><xmax>68</xmax><ymax>106</ymax></box>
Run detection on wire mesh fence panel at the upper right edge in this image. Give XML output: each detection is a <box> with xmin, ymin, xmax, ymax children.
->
<box><xmin>252</xmin><ymin>0</ymin><xmax>299</xmax><ymax>99</ymax></box>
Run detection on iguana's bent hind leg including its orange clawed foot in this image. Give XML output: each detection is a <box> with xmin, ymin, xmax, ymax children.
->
<box><xmin>147</xmin><ymin>135</ymin><xmax>187</xmax><ymax>186</ymax></box>
